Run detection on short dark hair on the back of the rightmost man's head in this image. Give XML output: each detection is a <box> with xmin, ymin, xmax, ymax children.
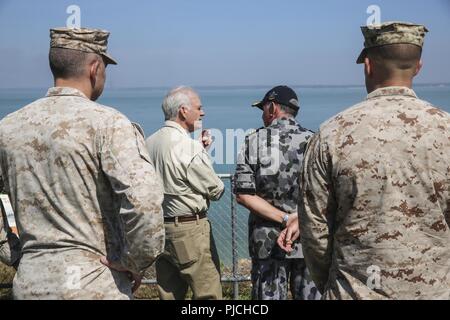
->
<box><xmin>367</xmin><ymin>43</ymin><xmax>422</xmax><ymax>71</ymax></box>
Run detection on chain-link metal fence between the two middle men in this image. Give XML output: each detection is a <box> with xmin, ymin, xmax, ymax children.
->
<box><xmin>0</xmin><ymin>174</ymin><xmax>250</xmax><ymax>300</ymax></box>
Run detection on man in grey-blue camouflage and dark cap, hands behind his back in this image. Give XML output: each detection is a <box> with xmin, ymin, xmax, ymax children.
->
<box><xmin>233</xmin><ymin>86</ymin><xmax>318</xmax><ymax>300</ymax></box>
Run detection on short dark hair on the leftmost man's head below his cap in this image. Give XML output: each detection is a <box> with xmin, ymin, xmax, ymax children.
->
<box><xmin>49</xmin><ymin>48</ymin><xmax>97</xmax><ymax>79</ymax></box>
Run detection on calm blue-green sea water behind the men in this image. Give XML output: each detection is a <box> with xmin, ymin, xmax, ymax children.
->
<box><xmin>0</xmin><ymin>84</ymin><xmax>450</xmax><ymax>265</ymax></box>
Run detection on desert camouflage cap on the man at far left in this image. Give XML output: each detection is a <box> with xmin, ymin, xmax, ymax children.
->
<box><xmin>50</xmin><ymin>28</ymin><xmax>117</xmax><ymax>64</ymax></box>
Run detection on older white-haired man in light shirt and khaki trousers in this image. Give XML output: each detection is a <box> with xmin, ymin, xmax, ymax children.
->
<box><xmin>147</xmin><ymin>87</ymin><xmax>224</xmax><ymax>300</ymax></box>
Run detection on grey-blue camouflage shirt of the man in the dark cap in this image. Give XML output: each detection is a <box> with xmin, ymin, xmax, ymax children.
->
<box><xmin>233</xmin><ymin>118</ymin><xmax>313</xmax><ymax>259</ymax></box>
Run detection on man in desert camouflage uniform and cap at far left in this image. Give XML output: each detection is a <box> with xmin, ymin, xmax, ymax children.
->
<box><xmin>0</xmin><ymin>28</ymin><xmax>164</xmax><ymax>299</ymax></box>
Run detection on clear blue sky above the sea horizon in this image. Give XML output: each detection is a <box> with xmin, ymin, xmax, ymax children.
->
<box><xmin>0</xmin><ymin>0</ymin><xmax>450</xmax><ymax>88</ymax></box>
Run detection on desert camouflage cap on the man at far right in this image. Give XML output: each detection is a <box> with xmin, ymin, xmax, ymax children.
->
<box><xmin>356</xmin><ymin>21</ymin><xmax>428</xmax><ymax>63</ymax></box>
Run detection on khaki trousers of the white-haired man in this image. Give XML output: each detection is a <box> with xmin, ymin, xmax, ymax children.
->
<box><xmin>156</xmin><ymin>218</ymin><xmax>222</xmax><ymax>300</ymax></box>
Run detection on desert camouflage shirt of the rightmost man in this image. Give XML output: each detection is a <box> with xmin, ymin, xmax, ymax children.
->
<box><xmin>299</xmin><ymin>87</ymin><xmax>450</xmax><ymax>299</ymax></box>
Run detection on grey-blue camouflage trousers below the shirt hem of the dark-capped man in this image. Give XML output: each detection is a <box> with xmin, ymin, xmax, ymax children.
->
<box><xmin>251</xmin><ymin>259</ymin><xmax>321</xmax><ymax>300</ymax></box>
